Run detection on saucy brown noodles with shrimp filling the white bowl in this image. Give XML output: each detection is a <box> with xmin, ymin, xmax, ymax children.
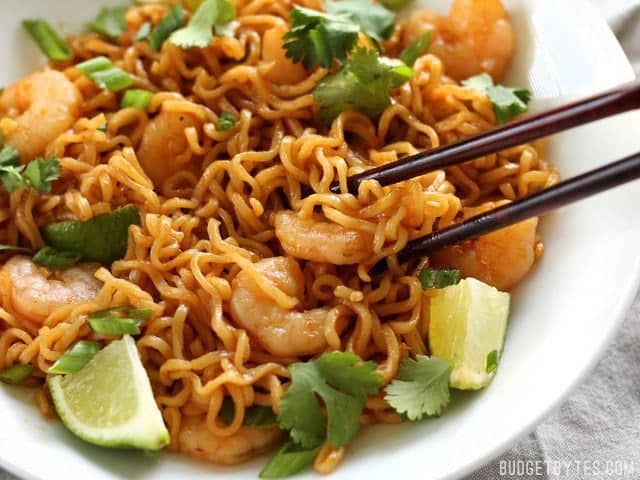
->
<box><xmin>0</xmin><ymin>0</ymin><xmax>559</xmax><ymax>473</ymax></box>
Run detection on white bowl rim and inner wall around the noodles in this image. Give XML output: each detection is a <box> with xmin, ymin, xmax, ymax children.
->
<box><xmin>0</xmin><ymin>0</ymin><xmax>640</xmax><ymax>480</ymax></box>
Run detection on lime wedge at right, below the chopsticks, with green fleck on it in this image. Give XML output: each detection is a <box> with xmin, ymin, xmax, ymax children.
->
<box><xmin>429</xmin><ymin>278</ymin><xmax>510</xmax><ymax>390</ymax></box>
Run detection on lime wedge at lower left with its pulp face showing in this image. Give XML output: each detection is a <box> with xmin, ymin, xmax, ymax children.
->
<box><xmin>49</xmin><ymin>336</ymin><xmax>169</xmax><ymax>450</ymax></box>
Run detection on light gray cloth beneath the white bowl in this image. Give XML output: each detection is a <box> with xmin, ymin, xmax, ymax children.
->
<box><xmin>0</xmin><ymin>0</ymin><xmax>640</xmax><ymax>480</ymax></box>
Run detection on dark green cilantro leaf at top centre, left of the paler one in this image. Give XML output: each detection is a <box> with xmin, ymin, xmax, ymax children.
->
<box><xmin>283</xmin><ymin>6</ymin><xmax>360</xmax><ymax>68</ymax></box>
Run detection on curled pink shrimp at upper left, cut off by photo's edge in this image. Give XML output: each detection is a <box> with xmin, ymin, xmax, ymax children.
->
<box><xmin>0</xmin><ymin>70</ymin><xmax>82</xmax><ymax>163</ymax></box>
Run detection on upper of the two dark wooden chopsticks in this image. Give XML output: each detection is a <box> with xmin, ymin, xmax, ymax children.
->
<box><xmin>331</xmin><ymin>81</ymin><xmax>640</xmax><ymax>195</ymax></box>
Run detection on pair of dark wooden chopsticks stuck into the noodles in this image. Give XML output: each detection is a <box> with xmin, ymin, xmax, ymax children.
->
<box><xmin>306</xmin><ymin>82</ymin><xmax>640</xmax><ymax>271</ymax></box>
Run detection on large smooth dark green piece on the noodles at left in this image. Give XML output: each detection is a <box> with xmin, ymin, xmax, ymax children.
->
<box><xmin>42</xmin><ymin>205</ymin><xmax>140</xmax><ymax>264</ymax></box>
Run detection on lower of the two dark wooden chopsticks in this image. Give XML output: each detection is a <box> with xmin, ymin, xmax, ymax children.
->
<box><xmin>372</xmin><ymin>153</ymin><xmax>640</xmax><ymax>273</ymax></box>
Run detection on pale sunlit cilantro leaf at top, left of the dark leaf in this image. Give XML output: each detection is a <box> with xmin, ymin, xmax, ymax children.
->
<box><xmin>169</xmin><ymin>0</ymin><xmax>236</xmax><ymax>48</ymax></box>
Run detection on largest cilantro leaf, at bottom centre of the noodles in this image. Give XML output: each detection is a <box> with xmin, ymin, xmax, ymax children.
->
<box><xmin>278</xmin><ymin>352</ymin><xmax>382</xmax><ymax>449</ymax></box>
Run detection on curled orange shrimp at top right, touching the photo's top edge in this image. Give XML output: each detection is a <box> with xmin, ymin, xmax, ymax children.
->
<box><xmin>403</xmin><ymin>0</ymin><xmax>515</xmax><ymax>81</ymax></box>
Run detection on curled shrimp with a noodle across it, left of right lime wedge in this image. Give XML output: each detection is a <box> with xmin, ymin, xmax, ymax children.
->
<box><xmin>230</xmin><ymin>257</ymin><xmax>340</xmax><ymax>357</ymax></box>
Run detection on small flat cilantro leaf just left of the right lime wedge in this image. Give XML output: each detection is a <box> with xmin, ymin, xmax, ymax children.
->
<box><xmin>384</xmin><ymin>355</ymin><xmax>452</xmax><ymax>421</ymax></box>
